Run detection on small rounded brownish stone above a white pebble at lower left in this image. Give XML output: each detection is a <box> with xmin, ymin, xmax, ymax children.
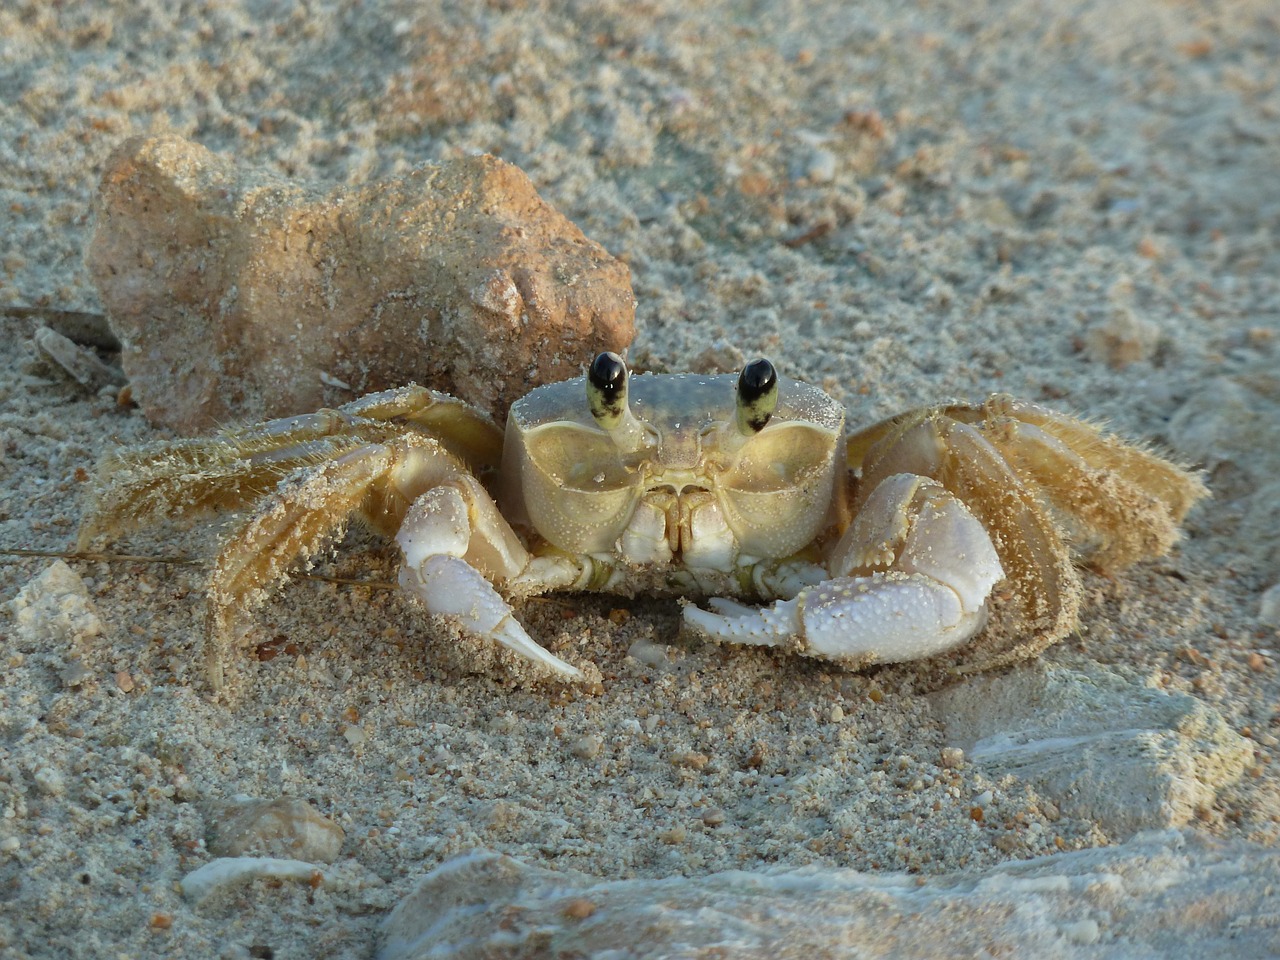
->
<box><xmin>207</xmin><ymin>796</ymin><xmax>347</xmax><ymax>863</ymax></box>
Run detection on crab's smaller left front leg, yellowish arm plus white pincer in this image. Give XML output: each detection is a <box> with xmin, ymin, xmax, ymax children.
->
<box><xmin>396</xmin><ymin>475</ymin><xmax>584</xmax><ymax>680</ymax></box>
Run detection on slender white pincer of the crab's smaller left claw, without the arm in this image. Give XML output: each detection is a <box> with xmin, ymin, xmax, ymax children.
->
<box><xmin>399</xmin><ymin>553</ymin><xmax>584</xmax><ymax>680</ymax></box>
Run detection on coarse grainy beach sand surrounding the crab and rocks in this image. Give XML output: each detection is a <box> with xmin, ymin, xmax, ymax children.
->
<box><xmin>0</xmin><ymin>0</ymin><xmax>1280</xmax><ymax>960</ymax></box>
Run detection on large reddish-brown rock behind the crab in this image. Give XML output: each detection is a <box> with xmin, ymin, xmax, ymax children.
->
<box><xmin>86</xmin><ymin>137</ymin><xmax>635</xmax><ymax>433</ymax></box>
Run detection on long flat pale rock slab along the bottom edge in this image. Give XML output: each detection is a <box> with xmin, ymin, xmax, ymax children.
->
<box><xmin>378</xmin><ymin>831</ymin><xmax>1280</xmax><ymax>960</ymax></box>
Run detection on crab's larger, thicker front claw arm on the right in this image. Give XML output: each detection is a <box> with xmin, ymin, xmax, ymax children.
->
<box><xmin>685</xmin><ymin>474</ymin><xmax>1005</xmax><ymax>667</ymax></box>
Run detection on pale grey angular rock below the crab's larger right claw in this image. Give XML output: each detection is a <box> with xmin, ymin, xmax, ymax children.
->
<box><xmin>931</xmin><ymin>664</ymin><xmax>1253</xmax><ymax>837</ymax></box>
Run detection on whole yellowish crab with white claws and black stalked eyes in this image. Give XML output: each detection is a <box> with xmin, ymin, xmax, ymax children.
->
<box><xmin>81</xmin><ymin>353</ymin><xmax>1206</xmax><ymax>690</ymax></box>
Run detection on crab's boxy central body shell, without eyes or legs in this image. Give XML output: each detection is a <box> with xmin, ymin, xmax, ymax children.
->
<box><xmin>499</xmin><ymin>374</ymin><xmax>847</xmax><ymax>571</ymax></box>
